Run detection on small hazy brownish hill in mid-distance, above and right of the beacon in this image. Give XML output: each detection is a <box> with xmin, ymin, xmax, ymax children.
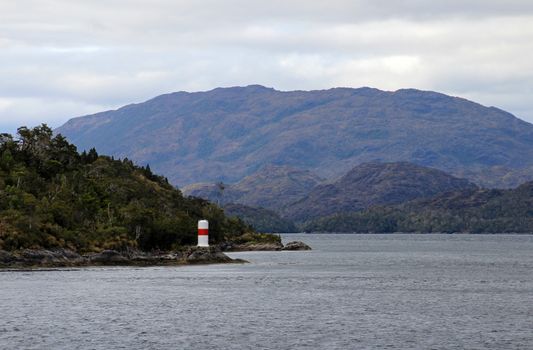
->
<box><xmin>183</xmin><ymin>165</ymin><xmax>323</xmax><ymax>211</ymax></box>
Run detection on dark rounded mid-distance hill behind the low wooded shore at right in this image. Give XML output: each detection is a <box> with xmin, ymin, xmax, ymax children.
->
<box><xmin>283</xmin><ymin>162</ymin><xmax>476</xmax><ymax>222</ymax></box>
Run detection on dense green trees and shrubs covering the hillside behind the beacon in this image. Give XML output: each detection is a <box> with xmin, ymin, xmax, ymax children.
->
<box><xmin>0</xmin><ymin>124</ymin><xmax>251</xmax><ymax>252</ymax></box>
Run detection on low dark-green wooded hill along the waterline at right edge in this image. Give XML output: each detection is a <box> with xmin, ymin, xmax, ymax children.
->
<box><xmin>304</xmin><ymin>182</ymin><xmax>533</xmax><ymax>233</ymax></box>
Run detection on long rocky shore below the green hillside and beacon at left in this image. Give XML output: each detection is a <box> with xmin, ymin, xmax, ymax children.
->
<box><xmin>0</xmin><ymin>247</ymin><xmax>246</xmax><ymax>269</ymax></box>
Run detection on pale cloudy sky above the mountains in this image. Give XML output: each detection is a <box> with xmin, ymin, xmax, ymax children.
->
<box><xmin>0</xmin><ymin>0</ymin><xmax>533</xmax><ymax>133</ymax></box>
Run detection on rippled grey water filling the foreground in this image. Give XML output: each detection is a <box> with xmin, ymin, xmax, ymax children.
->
<box><xmin>0</xmin><ymin>235</ymin><xmax>533</xmax><ymax>349</ymax></box>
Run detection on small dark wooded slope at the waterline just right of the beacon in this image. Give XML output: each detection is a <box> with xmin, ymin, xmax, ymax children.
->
<box><xmin>224</xmin><ymin>203</ymin><xmax>299</xmax><ymax>233</ymax></box>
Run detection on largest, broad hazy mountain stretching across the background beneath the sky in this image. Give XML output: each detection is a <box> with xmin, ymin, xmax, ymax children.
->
<box><xmin>56</xmin><ymin>85</ymin><xmax>533</xmax><ymax>186</ymax></box>
